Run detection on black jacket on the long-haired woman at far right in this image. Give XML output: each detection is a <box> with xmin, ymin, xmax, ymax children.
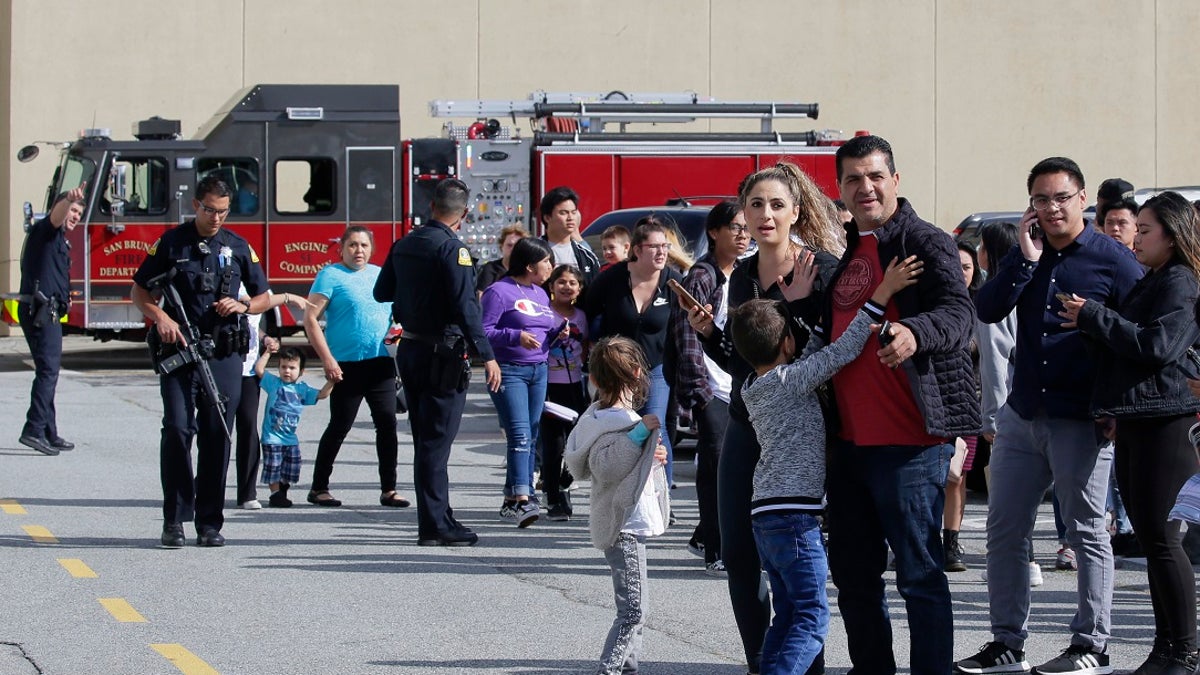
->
<box><xmin>1078</xmin><ymin>261</ymin><xmax>1200</xmax><ymax>417</ymax></box>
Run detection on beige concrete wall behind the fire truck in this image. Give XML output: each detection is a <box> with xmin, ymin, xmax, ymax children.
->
<box><xmin>0</xmin><ymin>0</ymin><xmax>1200</xmax><ymax>303</ymax></box>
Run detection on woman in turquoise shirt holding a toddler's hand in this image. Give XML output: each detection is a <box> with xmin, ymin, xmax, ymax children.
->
<box><xmin>304</xmin><ymin>225</ymin><xmax>409</xmax><ymax>507</ymax></box>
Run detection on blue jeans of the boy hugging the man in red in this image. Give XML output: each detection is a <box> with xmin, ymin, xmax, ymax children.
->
<box><xmin>751</xmin><ymin>513</ymin><xmax>829</xmax><ymax>675</ymax></box>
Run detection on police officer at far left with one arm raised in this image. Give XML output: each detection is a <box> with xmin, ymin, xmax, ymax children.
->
<box><xmin>17</xmin><ymin>184</ymin><xmax>88</xmax><ymax>455</ymax></box>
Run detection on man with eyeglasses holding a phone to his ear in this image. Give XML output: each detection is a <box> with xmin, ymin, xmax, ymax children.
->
<box><xmin>958</xmin><ymin>157</ymin><xmax>1142</xmax><ymax>675</ymax></box>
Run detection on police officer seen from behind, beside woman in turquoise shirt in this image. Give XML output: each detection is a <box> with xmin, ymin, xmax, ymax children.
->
<box><xmin>374</xmin><ymin>178</ymin><xmax>500</xmax><ymax>546</ymax></box>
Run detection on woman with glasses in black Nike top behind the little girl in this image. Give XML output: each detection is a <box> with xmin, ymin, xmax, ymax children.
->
<box><xmin>583</xmin><ymin>216</ymin><xmax>682</xmax><ymax>484</ymax></box>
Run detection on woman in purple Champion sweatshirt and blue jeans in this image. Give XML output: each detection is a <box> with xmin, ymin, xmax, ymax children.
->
<box><xmin>480</xmin><ymin>238</ymin><xmax>562</xmax><ymax>527</ymax></box>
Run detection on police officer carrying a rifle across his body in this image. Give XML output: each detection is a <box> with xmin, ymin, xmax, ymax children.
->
<box><xmin>132</xmin><ymin>178</ymin><xmax>270</xmax><ymax>548</ymax></box>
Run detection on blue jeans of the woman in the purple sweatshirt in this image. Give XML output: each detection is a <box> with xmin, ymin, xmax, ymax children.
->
<box><xmin>492</xmin><ymin>362</ymin><xmax>548</xmax><ymax>497</ymax></box>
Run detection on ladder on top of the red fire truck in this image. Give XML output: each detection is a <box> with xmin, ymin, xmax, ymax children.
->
<box><xmin>430</xmin><ymin>91</ymin><xmax>829</xmax><ymax>144</ymax></box>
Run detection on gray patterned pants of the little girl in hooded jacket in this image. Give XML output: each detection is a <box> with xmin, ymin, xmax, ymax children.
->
<box><xmin>599</xmin><ymin>532</ymin><xmax>646</xmax><ymax>675</ymax></box>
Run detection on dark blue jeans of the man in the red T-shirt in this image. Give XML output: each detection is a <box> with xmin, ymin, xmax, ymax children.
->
<box><xmin>826</xmin><ymin>441</ymin><xmax>955</xmax><ymax>675</ymax></box>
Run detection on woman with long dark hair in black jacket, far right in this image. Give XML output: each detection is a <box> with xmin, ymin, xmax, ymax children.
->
<box><xmin>1060</xmin><ymin>192</ymin><xmax>1200</xmax><ymax>675</ymax></box>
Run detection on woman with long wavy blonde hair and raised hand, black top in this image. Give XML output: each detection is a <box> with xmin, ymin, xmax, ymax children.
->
<box><xmin>688</xmin><ymin>162</ymin><xmax>845</xmax><ymax>673</ymax></box>
